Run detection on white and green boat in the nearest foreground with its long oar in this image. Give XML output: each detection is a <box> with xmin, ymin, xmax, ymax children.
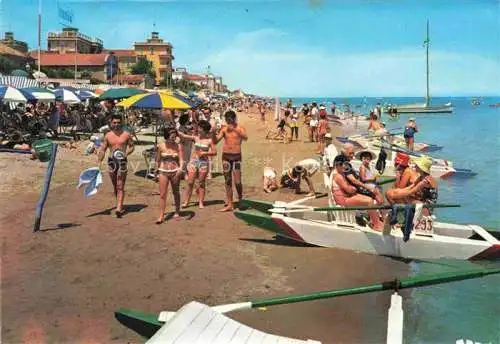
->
<box><xmin>115</xmin><ymin>268</ymin><xmax>500</xmax><ymax>344</ymax></box>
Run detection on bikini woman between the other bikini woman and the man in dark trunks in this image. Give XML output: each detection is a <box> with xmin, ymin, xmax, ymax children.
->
<box><xmin>180</xmin><ymin>120</ymin><xmax>217</xmax><ymax>209</ymax></box>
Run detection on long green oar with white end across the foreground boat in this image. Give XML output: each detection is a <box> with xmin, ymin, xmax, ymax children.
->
<box><xmin>205</xmin><ymin>268</ymin><xmax>500</xmax><ymax>313</ymax></box>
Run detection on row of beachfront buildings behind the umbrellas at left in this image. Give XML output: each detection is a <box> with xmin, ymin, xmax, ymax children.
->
<box><xmin>0</xmin><ymin>28</ymin><xmax>227</xmax><ymax>92</ymax></box>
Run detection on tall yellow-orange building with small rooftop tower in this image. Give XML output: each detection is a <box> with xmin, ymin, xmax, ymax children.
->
<box><xmin>134</xmin><ymin>32</ymin><xmax>174</xmax><ymax>86</ymax></box>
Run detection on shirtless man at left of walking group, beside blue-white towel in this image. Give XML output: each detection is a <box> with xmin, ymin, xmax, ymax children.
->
<box><xmin>97</xmin><ymin>115</ymin><xmax>134</xmax><ymax>218</ymax></box>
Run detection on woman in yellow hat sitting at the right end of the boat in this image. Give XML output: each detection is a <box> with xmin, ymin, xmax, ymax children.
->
<box><xmin>386</xmin><ymin>156</ymin><xmax>438</xmax><ymax>210</ymax></box>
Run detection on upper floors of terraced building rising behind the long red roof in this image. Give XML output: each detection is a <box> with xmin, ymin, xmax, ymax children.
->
<box><xmin>47</xmin><ymin>27</ymin><xmax>103</xmax><ymax>54</ymax></box>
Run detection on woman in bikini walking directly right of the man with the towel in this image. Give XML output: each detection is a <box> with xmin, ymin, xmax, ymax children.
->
<box><xmin>156</xmin><ymin>127</ymin><xmax>184</xmax><ymax>224</ymax></box>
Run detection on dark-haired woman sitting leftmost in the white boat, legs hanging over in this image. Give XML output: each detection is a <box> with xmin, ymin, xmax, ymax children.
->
<box><xmin>331</xmin><ymin>154</ymin><xmax>384</xmax><ymax>231</ymax></box>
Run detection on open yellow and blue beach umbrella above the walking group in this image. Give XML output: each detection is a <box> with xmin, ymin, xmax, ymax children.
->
<box><xmin>116</xmin><ymin>92</ymin><xmax>192</xmax><ymax>110</ymax></box>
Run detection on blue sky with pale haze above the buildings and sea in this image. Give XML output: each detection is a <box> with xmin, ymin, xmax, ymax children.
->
<box><xmin>0</xmin><ymin>0</ymin><xmax>500</xmax><ymax>97</ymax></box>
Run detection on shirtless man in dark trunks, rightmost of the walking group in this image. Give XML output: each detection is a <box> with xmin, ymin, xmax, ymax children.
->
<box><xmin>214</xmin><ymin>110</ymin><xmax>248</xmax><ymax>211</ymax></box>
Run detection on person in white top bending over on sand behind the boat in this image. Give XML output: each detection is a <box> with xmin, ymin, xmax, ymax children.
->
<box><xmin>280</xmin><ymin>159</ymin><xmax>321</xmax><ymax>196</ymax></box>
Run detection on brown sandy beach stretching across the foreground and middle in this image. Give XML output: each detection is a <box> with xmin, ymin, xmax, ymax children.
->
<box><xmin>0</xmin><ymin>109</ymin><xmax>407</xmax><ymax>343</ymax></box>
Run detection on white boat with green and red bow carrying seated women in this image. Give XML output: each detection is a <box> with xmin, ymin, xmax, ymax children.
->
<box><xmin>235</xmin><ymin>195</ymin><xmax>500</xmax><ymax>260</ymax></box>
